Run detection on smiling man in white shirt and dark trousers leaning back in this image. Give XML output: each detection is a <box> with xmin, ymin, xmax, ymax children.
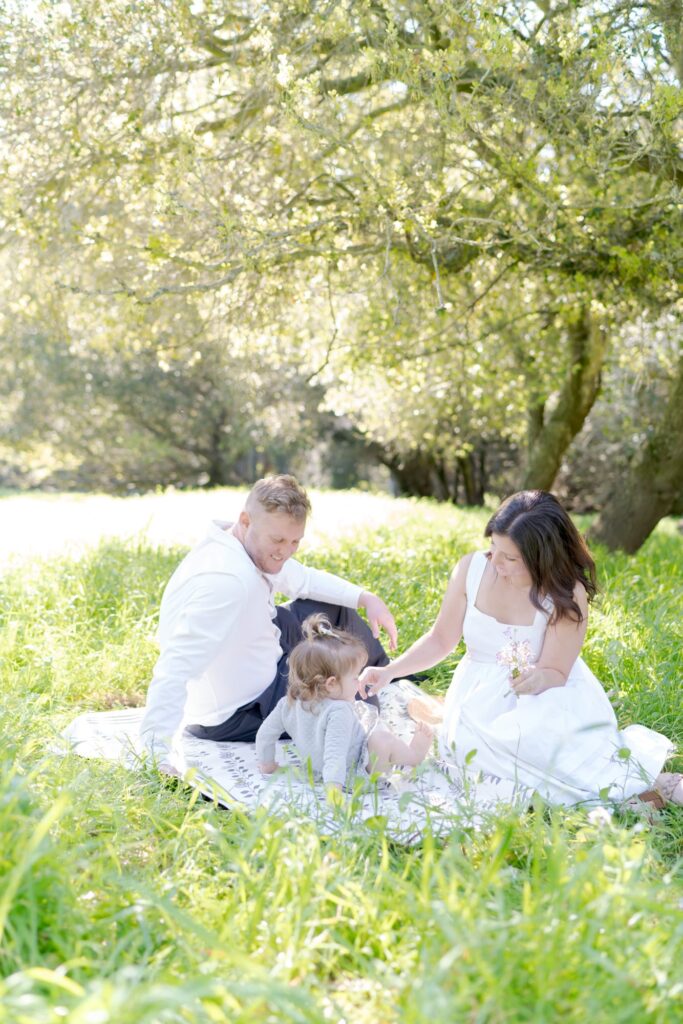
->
<box><xmin>140</xmin><ymin>475</ymin><xmax>396</xmax><ymax>770</ymax></box>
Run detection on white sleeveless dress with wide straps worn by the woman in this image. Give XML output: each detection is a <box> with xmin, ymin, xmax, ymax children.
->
<box><xmin>439</xmin><ymin>551</ymin><xmax>673</xmax><ymax>804</ymax></box>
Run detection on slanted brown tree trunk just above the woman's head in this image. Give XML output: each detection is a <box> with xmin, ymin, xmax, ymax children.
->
<box><xmin>523</xmin><ymin>306</ymin><xmax>606</xmax><ymax>490</ymax></box>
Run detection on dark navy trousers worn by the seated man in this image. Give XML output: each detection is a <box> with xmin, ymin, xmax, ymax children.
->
<box><xmin>187</xmin><ymin>598</ymin><xmax>389</xmax><ymax>742</ymax></box>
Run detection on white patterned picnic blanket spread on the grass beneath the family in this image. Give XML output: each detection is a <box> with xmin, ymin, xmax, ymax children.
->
<box><xmin>61</xmin><ymin>680</ymin><xmax>531</xmax><ymax>842</ymax></box>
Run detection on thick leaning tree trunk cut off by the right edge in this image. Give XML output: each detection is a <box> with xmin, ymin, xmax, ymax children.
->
<box><xmin>589</xmin><ymin>358</ymin><xmax>683</xmax><ymax>554</ymax></box>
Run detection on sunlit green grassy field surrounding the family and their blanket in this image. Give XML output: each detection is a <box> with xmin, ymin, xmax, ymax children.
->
<box><xmin>0</xmin><ymin>496</ymin><xmax>683</xmax><ymax>1024</ymax></box>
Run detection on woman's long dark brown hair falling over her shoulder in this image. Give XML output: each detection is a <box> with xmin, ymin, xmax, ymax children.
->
<box><xmin>484</xmin><ymin>490</ymin><xmax>598</xmax><ymax>623</ymax></box>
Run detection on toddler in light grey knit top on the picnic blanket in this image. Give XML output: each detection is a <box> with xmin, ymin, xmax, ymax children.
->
<box><xmin>256</xmin><ymin>614</ymin><xmax>433</xmax><ymax>790</ymax></box>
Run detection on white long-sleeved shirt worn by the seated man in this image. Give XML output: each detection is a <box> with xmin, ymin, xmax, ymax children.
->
<box><xmin>140</xmin><ymin>522</ymin><xmax>362</xmax><ymax>757</ymax></box>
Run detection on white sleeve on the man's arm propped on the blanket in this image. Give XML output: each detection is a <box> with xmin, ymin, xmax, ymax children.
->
<box><xmin>140</xmin><ymin>572</ymin><xmax>245</xmax><ymax>758</ymax></box>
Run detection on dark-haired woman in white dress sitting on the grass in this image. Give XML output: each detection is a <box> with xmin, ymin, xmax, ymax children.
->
<box><xmin>360</xmin><ymin>490</ymin><xmax>683</xmax><ymax>804</ymax></box>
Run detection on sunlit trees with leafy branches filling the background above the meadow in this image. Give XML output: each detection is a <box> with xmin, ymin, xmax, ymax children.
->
<box><xmin>0</xmin><ymin>0</ymin><xmax>683</xmax><ymax>550</ymax></box>
